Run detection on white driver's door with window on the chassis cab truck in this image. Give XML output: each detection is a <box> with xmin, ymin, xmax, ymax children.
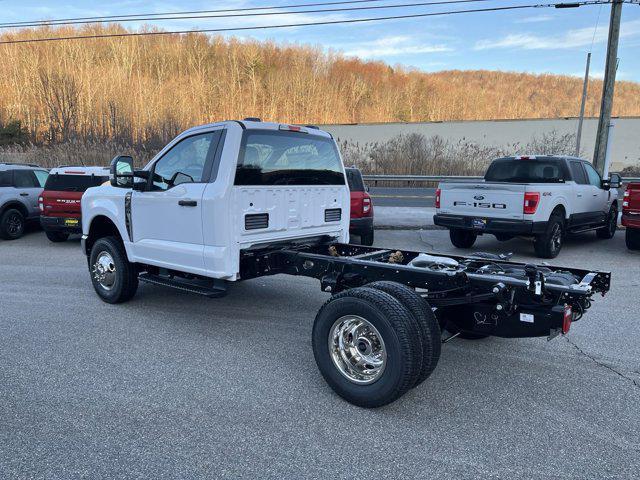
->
<box><xmin>131</xmin><ymin>130</ymin><xmax>221</xmax><ymax>273</ymax></box>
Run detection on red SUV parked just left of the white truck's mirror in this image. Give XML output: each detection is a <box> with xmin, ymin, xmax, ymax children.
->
<box><xmin>38</xmin><ymin>165</ymin><xmax>109</xmax><ymax>242</ymax></box>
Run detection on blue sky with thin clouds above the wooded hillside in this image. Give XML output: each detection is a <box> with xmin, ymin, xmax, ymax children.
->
<box><xmin>0</xmin><ymin>0</ymin><xmax>640</xmax><ymax>81</ymax></box>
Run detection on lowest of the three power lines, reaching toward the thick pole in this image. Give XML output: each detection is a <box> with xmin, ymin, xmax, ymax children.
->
<box><xmin>0</xmin><ymin>0</ymin><xmax>609</xmax><ymax>45</ymax></box>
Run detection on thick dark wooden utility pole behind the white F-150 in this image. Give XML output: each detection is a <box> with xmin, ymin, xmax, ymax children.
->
<box><xmin>593</xmin><ymin>0</ymin><xmax>623</xmax><ymax>175</ymax></box>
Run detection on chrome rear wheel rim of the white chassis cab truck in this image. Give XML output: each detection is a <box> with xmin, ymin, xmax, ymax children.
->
<box><xmin>329</xmin><ymin>315</ymin><xmax>387</xmax><ymax>385</ymax></box>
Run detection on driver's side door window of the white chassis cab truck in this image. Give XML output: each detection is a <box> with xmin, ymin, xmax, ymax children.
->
<box><xmin>152</xmin><ymin>132</ymin><xmax>216</xmax><ymax>190</ymax></box>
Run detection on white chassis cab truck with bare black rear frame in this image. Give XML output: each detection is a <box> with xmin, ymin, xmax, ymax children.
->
<box><xmin>82</xmin><ymin>119</ymin><xmax>610</xmax><ymax>407</ymax></box>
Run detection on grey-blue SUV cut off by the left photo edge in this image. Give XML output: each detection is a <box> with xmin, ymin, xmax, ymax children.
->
<box><xmin>0</xmin><ymin>163</ymin><xmax>49</xmax><ymax>240</ymax></box>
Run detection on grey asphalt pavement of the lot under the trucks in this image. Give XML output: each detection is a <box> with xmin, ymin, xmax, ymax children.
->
<box><xmin>0</xmin><ymin>230</ymin><xmax>640</xmax><ymax>480</ymax></box>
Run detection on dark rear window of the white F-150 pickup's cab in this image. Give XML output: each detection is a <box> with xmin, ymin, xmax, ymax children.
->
<box><xmin>484</xmin><ymin>158</ymin><xmax>566</xmax><ymax>183</ymax></box>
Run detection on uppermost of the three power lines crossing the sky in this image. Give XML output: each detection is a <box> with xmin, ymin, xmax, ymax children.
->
<box><xmin>0</xmin><ymin>0</ymin><xmax>489</xmax><ymax>27</ymax></box>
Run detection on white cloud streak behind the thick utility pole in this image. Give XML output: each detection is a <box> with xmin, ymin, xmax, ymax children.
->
<box><xmin>474</xmin><ymin>20</ymin><xmax>640</xmax><ymax>50</ymax></box>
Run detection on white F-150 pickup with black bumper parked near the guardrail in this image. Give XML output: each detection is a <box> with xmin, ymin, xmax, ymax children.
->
<box><xmin>434</xmin><ymin>156</ymin><xmax>620</xmax><ymax>258</ymax></box>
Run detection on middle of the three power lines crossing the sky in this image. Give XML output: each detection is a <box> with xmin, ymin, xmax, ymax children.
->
<box><xmin>0</xmin><ymin>0</ymin><xmax>490</xmax><ymax>29</ymax></box>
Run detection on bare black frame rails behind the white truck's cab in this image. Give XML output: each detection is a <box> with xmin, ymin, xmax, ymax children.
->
<box><xmin>241</xmin><ymin>242</ymin><xmax>611</xmax><ymax>339</ymax></box>
